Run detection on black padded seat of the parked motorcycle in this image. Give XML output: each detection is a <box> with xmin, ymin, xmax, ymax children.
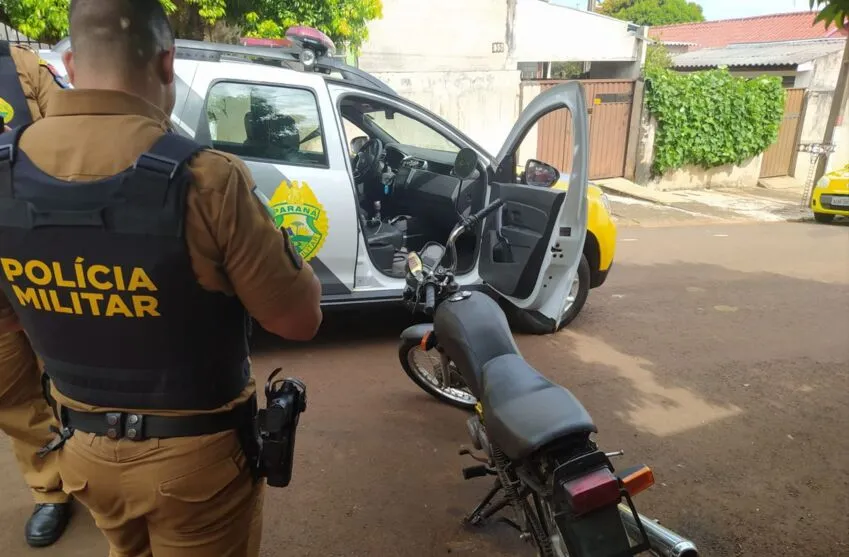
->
<box><xmin>481</xmin><ymin>354</ymin><xmax>598</xmax><ymax>460</ymax></box>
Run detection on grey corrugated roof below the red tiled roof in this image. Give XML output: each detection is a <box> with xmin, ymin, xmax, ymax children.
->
<box><xmin>672</xmin><ymin>39</ymin><xmax>846</xmax><ymax>68</ymax></box>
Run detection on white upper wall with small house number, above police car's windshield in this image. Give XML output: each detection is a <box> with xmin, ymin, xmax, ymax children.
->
<box><xmin>359</xmin><ymin>0</ymin><xmax>506</xmax><ymax>72</ymax></box>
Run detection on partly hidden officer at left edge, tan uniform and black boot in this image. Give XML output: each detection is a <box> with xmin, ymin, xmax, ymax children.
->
<box><xmin>0</xmin><ymin>41</ymin><xmax>71</xmax><ymax>547</ymax></box>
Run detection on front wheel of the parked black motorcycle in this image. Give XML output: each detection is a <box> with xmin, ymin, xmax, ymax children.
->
<box><xmin>398</xmin><ymin>339</ymin><xmax>478</xmax><ymax>410</ymax></box>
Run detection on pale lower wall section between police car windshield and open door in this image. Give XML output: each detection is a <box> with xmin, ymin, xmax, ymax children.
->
<box><xmin>375</xmin><ymin>70</ymin><xmax>519</xmax><ymax>155</ymax></box>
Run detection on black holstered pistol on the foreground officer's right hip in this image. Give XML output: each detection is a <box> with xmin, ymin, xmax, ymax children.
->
<box><xmin>256</xmin><ymin>368</ymin><xmax>307</xmax><ymax>487</ymax></box>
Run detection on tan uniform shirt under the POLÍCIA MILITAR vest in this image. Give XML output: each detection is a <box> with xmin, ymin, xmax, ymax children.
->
<box><xmin>0</xmin><ymin>89</ymin><xmax>313</xmax><ymax>415</ymax></box>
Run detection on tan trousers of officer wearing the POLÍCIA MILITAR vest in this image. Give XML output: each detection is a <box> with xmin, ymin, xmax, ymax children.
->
<box><xmin>59</xmin><ymin>431</ymin><xmax>264</xmax><ymax>557</ymax></box>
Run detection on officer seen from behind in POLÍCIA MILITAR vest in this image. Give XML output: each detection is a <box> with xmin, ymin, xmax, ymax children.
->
<box><xmin>0</xmin><ymin>0</ymin><xmax>322</xmax><ymax>557</ymax></box>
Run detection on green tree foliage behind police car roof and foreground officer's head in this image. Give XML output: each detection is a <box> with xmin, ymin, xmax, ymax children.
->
<box><xmin>0</xmin><ymin>0</ymin><xmax>383</xmax><ymax>52</ymax></box>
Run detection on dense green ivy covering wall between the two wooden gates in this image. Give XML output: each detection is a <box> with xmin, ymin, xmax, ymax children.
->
<box><xmin>646</xmin><ymin>68</ymin><xmax>785</xmax><ymax>174</ymax></box>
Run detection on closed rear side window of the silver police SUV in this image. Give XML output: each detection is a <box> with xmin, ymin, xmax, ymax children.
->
<box><xmin>206</xmin><ymin>82</ymin><xmax>327</xmax><ymax>167</ymax></box>
